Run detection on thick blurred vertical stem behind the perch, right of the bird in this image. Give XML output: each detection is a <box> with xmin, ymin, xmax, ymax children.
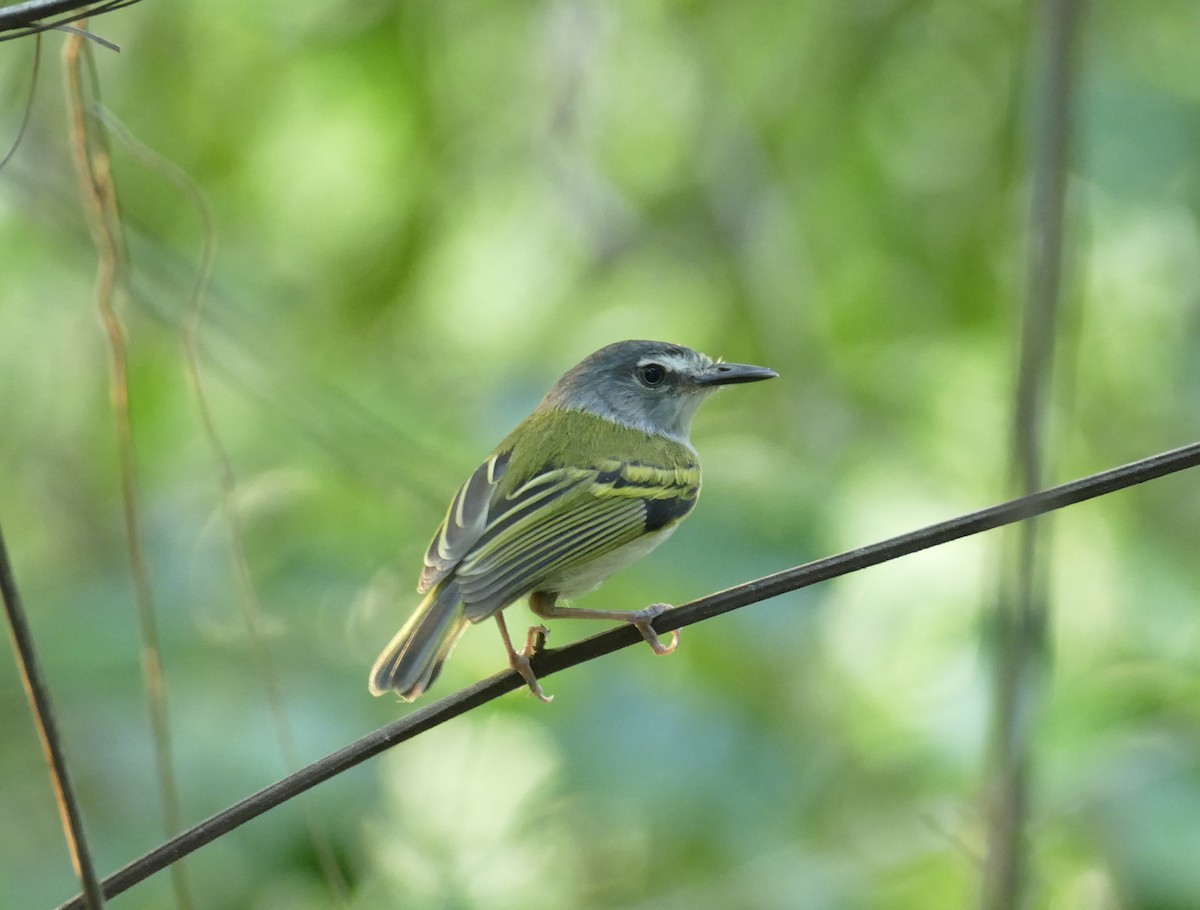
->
<box><xmin>980</xmin><ymin>0</ymin><xmax>1081</xmax><ymax>910</ymax></box>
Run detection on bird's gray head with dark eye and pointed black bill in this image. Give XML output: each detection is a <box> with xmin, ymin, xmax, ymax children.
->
<box><xmin>539</xmin><ymin>341</ymin><xmax>778</xmax><ymax>442</ymax></box>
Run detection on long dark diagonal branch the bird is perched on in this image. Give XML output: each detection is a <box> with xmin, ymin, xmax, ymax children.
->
<box><xmin>51</xmin><ymin>442</ymin><xmax>1200</xmax><ymax>910</ymax></box>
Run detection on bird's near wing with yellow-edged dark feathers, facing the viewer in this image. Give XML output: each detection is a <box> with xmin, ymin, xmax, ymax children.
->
<box><xmin>455</xmin><ymin>461</ymin><xmax>700</xmax><ymax>622</ymax></box>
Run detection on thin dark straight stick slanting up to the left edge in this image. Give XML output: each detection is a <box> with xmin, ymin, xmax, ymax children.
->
<box><xmin>0</xmin><ymin>531</ymin><xmax>104</xmax><ymax>910</ymax></box>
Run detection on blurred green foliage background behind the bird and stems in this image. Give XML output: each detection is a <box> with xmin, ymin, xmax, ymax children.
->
<box><xmin>0</xmin><ymin>0</ymin><xmax>1200</xmax><ymax>910</ymax></box>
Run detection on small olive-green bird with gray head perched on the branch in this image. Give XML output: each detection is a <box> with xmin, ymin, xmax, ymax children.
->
<box><xmin>370</xmin><ymin>341</ymin><xmax>778</xmax><ymax>701</ymax></box>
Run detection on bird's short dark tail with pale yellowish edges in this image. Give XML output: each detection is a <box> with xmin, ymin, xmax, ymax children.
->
<box><xmin>370</xmin><ymin>579</ymin><xmax>470</xmax><ymax>701</ymax></box>
